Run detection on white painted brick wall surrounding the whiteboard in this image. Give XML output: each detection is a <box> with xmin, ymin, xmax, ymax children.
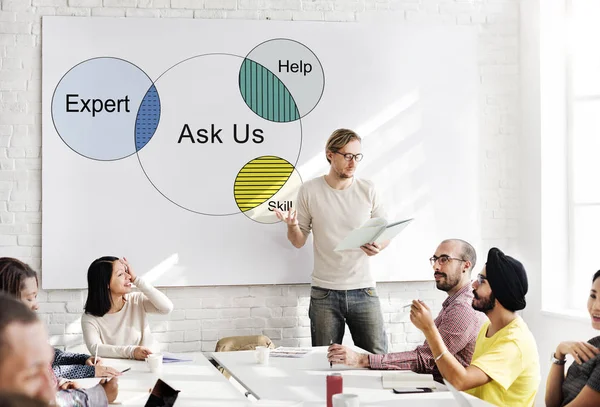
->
<box><xmin>0</xmin><ymin>0</ymin><xmax>520</xmax><ymax>352</ymax></box>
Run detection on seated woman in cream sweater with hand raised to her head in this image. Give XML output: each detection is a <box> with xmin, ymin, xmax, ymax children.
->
<box><xmin>81</xmin><ymin>256</ymin><xmax>173</xmax><ymax>360</ymax></box>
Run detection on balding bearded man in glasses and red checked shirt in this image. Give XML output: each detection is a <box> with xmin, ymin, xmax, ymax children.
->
<box><xmin>327</xmin><ymin>239</ymin><xmax>485</xmax><ymax>382</ymax></box>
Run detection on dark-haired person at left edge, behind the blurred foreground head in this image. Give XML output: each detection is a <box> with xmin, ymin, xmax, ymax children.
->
<box><xmin>0</xmin><ymin>257</ymin><xmax>120</xmax><ymax>379</ymax></box>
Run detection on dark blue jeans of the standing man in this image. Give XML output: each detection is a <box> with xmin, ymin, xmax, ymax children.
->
<box><xmin>308</xmin><ymin>287</ymin><xmax>387</xmax><ymax>354</ymax></box>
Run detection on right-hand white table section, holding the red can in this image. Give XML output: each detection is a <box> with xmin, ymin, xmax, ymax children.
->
<box><xmin>211</xmin><ymin>346</ymin><xmax>490</xmax><ymax>407</ymax></box>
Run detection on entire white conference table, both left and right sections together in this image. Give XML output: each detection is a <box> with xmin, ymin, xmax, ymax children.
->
<box><xmin>74</xmin><ymin>347</ymin><xmax>491</xmax><ymax>407</ymax></box>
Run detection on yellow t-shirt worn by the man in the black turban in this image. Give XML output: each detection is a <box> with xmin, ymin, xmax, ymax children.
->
<box><xmin>467</xmin><ymin>317</ymin><xmax>540</xmax><ymax>407</ymax></box>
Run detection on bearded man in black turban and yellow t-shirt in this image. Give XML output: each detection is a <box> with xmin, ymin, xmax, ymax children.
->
<box><xmin>410</xmin><ymin>247</ymin><xmax>540</xmax><ymax>407</ymax></box>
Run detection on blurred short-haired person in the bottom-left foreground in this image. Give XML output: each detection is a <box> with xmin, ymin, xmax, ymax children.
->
<box><xmin>0</xmin><ymin>293</ymin><xmax>118</xmax><ymax>407</ymax></box>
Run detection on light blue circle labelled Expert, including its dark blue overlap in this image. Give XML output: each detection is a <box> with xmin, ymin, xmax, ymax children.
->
<box><xmin>51</xmin><ymin>57</ymin><xmax>160</xmax><ymax>161</ymax></box>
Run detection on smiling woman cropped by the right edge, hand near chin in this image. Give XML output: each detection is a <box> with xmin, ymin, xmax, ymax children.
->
<box><xmin>546</xmin><ymin>270</ymin><xmax>600</xmax><ymax>407</ymax></box>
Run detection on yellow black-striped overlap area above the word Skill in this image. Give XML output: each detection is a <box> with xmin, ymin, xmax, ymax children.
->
<box><xmin>233</xmin><ymin>155</ymin><xmax>294</xmax><ymax>212</ymax></box>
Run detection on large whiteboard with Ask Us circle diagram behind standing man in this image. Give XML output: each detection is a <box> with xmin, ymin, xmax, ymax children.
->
<box><xmin>42</xmin><ymin>17</ymin><xmax>480</xmax><ymax>289</ymax></box>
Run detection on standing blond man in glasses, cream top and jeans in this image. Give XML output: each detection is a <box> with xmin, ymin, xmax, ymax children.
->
<box><xmin>275</xmin><ymin>129</ymin><xmax>389</xmax><ymax>353</ymax></box>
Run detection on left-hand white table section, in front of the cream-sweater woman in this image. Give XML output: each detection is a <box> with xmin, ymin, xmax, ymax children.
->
<box><xmin>75</xmin><ymin>353</ymin><xmax>251</xmax><ymax>407</ymax></box>
